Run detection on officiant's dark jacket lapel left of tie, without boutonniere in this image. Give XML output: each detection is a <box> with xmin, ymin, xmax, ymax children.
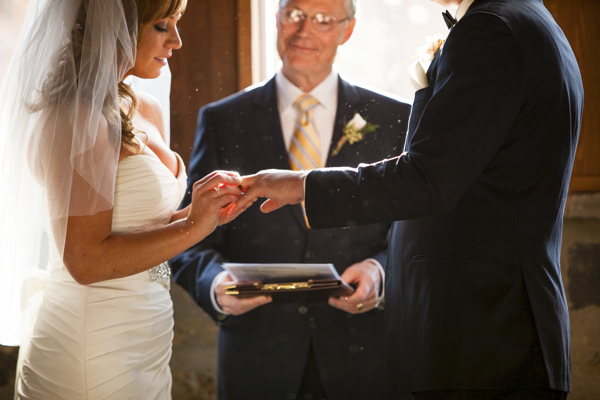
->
<box><xmin>253</xmin><ymin>78</ymin><xmax>308</xmax><ymax>231</ymax></box>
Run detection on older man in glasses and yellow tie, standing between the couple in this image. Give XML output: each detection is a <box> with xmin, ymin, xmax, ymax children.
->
<box><xmin>172</xmin><ymin>0</ymin><xmax>412</xmax><ymax>400</ymax></box>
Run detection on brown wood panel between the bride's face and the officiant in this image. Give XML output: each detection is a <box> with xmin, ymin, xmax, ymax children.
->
<box><xmin>169</xmin><ymin>0</ymin><xmax>238</xmax><ymax>163</ymax></box>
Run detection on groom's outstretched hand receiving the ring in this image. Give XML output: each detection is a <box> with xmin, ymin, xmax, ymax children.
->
<box><xmin>231</xmin><ymin>169</ymin><xmax>309</xmax><ymax>213</ymax></box>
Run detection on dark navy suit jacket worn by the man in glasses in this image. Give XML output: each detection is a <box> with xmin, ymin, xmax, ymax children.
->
<box><xmin>172</xmin><ymin>79</ymin><xmax>410</xmax><ymax>400</ymax></box>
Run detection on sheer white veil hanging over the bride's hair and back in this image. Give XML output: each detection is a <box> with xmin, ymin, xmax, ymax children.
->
<box><xmin>0</xmin><ymin>0</ymin><xmax>137</xmax><ymax>345</ymax></box>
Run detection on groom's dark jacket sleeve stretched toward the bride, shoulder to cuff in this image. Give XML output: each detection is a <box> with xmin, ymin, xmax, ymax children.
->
<box><xmin>306</xmin><ymin>13</ymin><xmax>528</xmax><ymax>228</ymax></box>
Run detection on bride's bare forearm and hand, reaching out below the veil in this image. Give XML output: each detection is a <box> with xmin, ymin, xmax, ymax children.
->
<box><xmin>63</xmin><ymin>172</ymin><xmax>241</xmax><ymax>285</ymax></box>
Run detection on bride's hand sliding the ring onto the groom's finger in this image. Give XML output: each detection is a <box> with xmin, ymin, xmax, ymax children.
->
<box><xmin>187</xmin><ymin>171</ymin><xmax>247</xmax><ymax>238</ymax></box>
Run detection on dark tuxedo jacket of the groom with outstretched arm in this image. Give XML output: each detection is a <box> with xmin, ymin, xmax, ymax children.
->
<box><xmin>306</xmin><ymin>0</ymin><xmax>583</xmax><ymax>391</ymax></box>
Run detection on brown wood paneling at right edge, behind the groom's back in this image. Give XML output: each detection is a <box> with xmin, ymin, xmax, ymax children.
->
<box><xmin>544</xmin><ymin>0</ymin><xmax>600</xmax><ymax>192</ymax></box>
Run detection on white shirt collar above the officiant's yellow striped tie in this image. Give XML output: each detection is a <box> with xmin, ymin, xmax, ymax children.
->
<box><xmin>275</xmin><ymin>68</ymin><xmax>338</xmax><ymax>110</ymax></box>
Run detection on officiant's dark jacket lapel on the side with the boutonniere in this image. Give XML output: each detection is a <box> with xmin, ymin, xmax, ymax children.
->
<box><xmin>326</xmin><ymin>78</ymin><xmax>361</xmax><ymax>167</ymax></box>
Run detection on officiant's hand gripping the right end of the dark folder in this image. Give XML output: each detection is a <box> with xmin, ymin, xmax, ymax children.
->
<box><xmin>329</xmin><ymin>260</ymin><xmax>381</xmax><ymax>314</ymax></box>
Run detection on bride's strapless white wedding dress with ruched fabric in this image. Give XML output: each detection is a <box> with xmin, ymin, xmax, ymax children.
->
<box><xmin>15</xmin><ymin>155</ymin><xmax>186</xmax><ymax>400</ymax></box>
